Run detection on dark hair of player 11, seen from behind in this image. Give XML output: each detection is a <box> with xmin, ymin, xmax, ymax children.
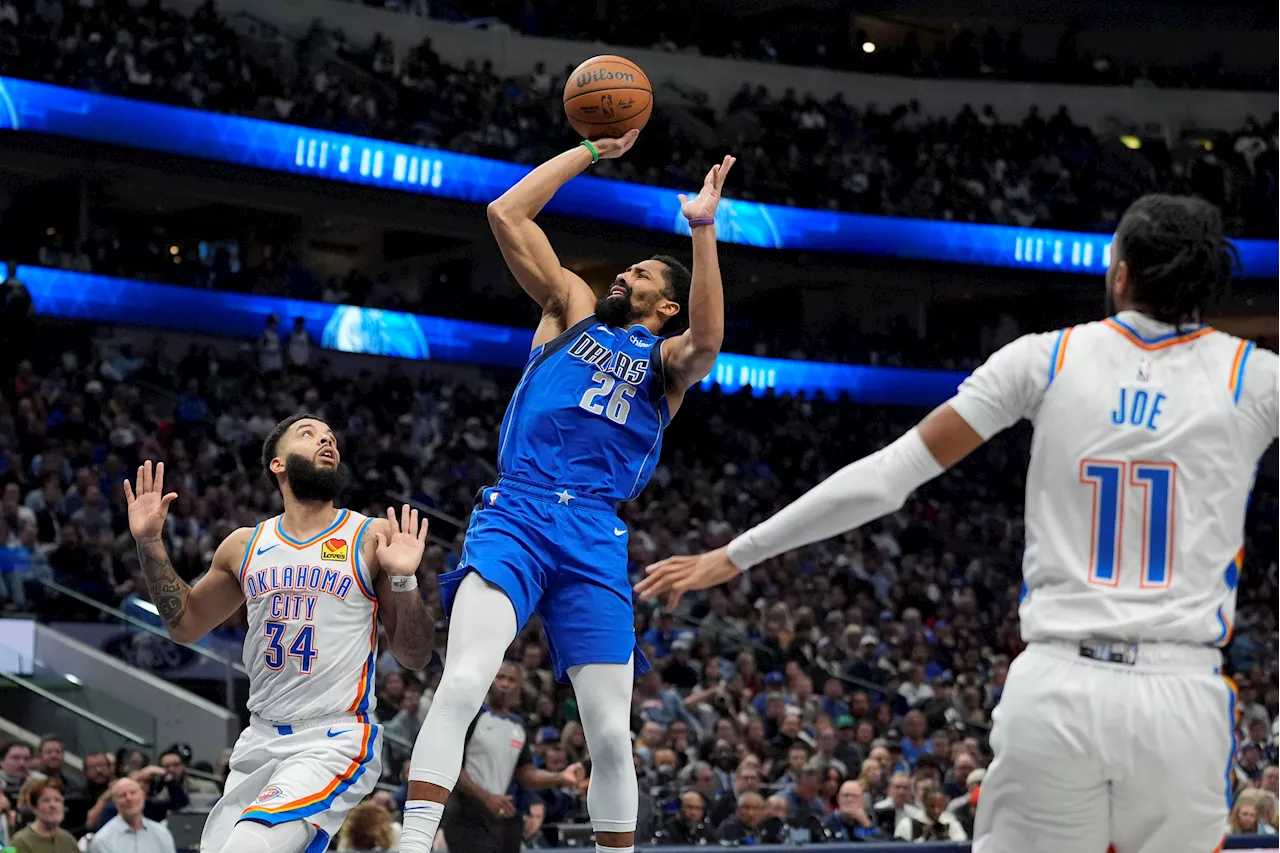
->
<box><xmin>1114</xmin><ymin>193</ymin><xmax>1240</xmax><ymax>325</ymax></box>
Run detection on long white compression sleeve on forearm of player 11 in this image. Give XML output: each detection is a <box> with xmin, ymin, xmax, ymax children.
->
<box><xmin>728</xmin><ymin>428</ymin><xmax>942</xmax><ymax>571</ymax></box>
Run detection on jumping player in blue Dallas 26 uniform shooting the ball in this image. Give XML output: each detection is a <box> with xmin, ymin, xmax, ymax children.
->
<box><xmin>401</xmin><ymin>139</ymin><xmax>733</xmax><ymax>853</ymax></box>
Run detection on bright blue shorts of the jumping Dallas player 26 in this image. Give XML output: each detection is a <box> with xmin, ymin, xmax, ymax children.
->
<box><xmin>440</xmin><ymin>479</ymin><xmax>649</xmax><ymax>681</ymax></box>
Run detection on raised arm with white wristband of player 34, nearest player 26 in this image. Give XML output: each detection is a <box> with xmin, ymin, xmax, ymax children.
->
<box><xmin>360</xmin><ymin>503</ymin><xmax>435</xmax><ymax>670</ymax></box>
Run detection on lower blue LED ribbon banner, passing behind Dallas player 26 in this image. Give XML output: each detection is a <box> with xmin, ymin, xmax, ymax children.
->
<box><xmin>18</xmin><ymin>266</ymin><xmax>965</xmax><ymax>406</ymax></box>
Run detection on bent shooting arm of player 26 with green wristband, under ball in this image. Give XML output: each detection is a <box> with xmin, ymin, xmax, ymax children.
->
<box><xmin>489</xmin><ymin>131</ymin><xmax>640</xmax><ymax>316</ymax></box>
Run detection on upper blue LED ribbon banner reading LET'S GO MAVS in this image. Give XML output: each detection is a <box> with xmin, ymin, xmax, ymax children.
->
<box><xmin>0</xmin><ymin>77</ymin><xmax>1280</xmax><ymax>278</ymax></box>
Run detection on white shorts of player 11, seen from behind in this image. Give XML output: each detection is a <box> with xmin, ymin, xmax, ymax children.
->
<box><xmin>973</xmin><ymin>642</ymin><xmax>1236</xmax><ymax>853</ymax></box>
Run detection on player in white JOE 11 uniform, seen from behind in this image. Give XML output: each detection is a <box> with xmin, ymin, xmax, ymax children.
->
<box><xmin>636</xmin><ymin>195</ymin><xmax>1259</xmax><ymax>853</ymax></box>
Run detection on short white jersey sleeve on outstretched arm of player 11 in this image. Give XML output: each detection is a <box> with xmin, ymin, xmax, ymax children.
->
<box><xmin>950</xmin><ymin>329</ymin><xmax>1054</xmax><ymax>441</ymax></box>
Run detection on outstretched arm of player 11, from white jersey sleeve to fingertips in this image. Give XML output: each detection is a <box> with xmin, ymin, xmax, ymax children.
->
<box><xmin>635</xmin><ymin>336</ymin><xmax>1052</xmax><ymax>610</ymax></box>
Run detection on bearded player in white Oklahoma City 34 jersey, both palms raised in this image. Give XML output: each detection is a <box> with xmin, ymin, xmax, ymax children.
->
<box><xmin>124</xmin><ymin>414</ymin><xmax>435</xmax><ymax>853</ymax></box>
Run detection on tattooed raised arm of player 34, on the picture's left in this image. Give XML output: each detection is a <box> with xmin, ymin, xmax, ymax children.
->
<box><xmin>124</xmin><ymin>460</ymin><xmax>252</xmax><ymax>643</ymax></box>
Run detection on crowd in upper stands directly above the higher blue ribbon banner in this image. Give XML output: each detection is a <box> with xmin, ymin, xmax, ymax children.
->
<box><xmin>0</xmin><ymin>0</ymin><xmax>1280</xmax><ymax>236</ymax></box>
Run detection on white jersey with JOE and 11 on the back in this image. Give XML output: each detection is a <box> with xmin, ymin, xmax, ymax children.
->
<box><xmin>951</xmin><ymin>311</ymin><xmax>1280</xmax><ymax>646</ymax></box>
